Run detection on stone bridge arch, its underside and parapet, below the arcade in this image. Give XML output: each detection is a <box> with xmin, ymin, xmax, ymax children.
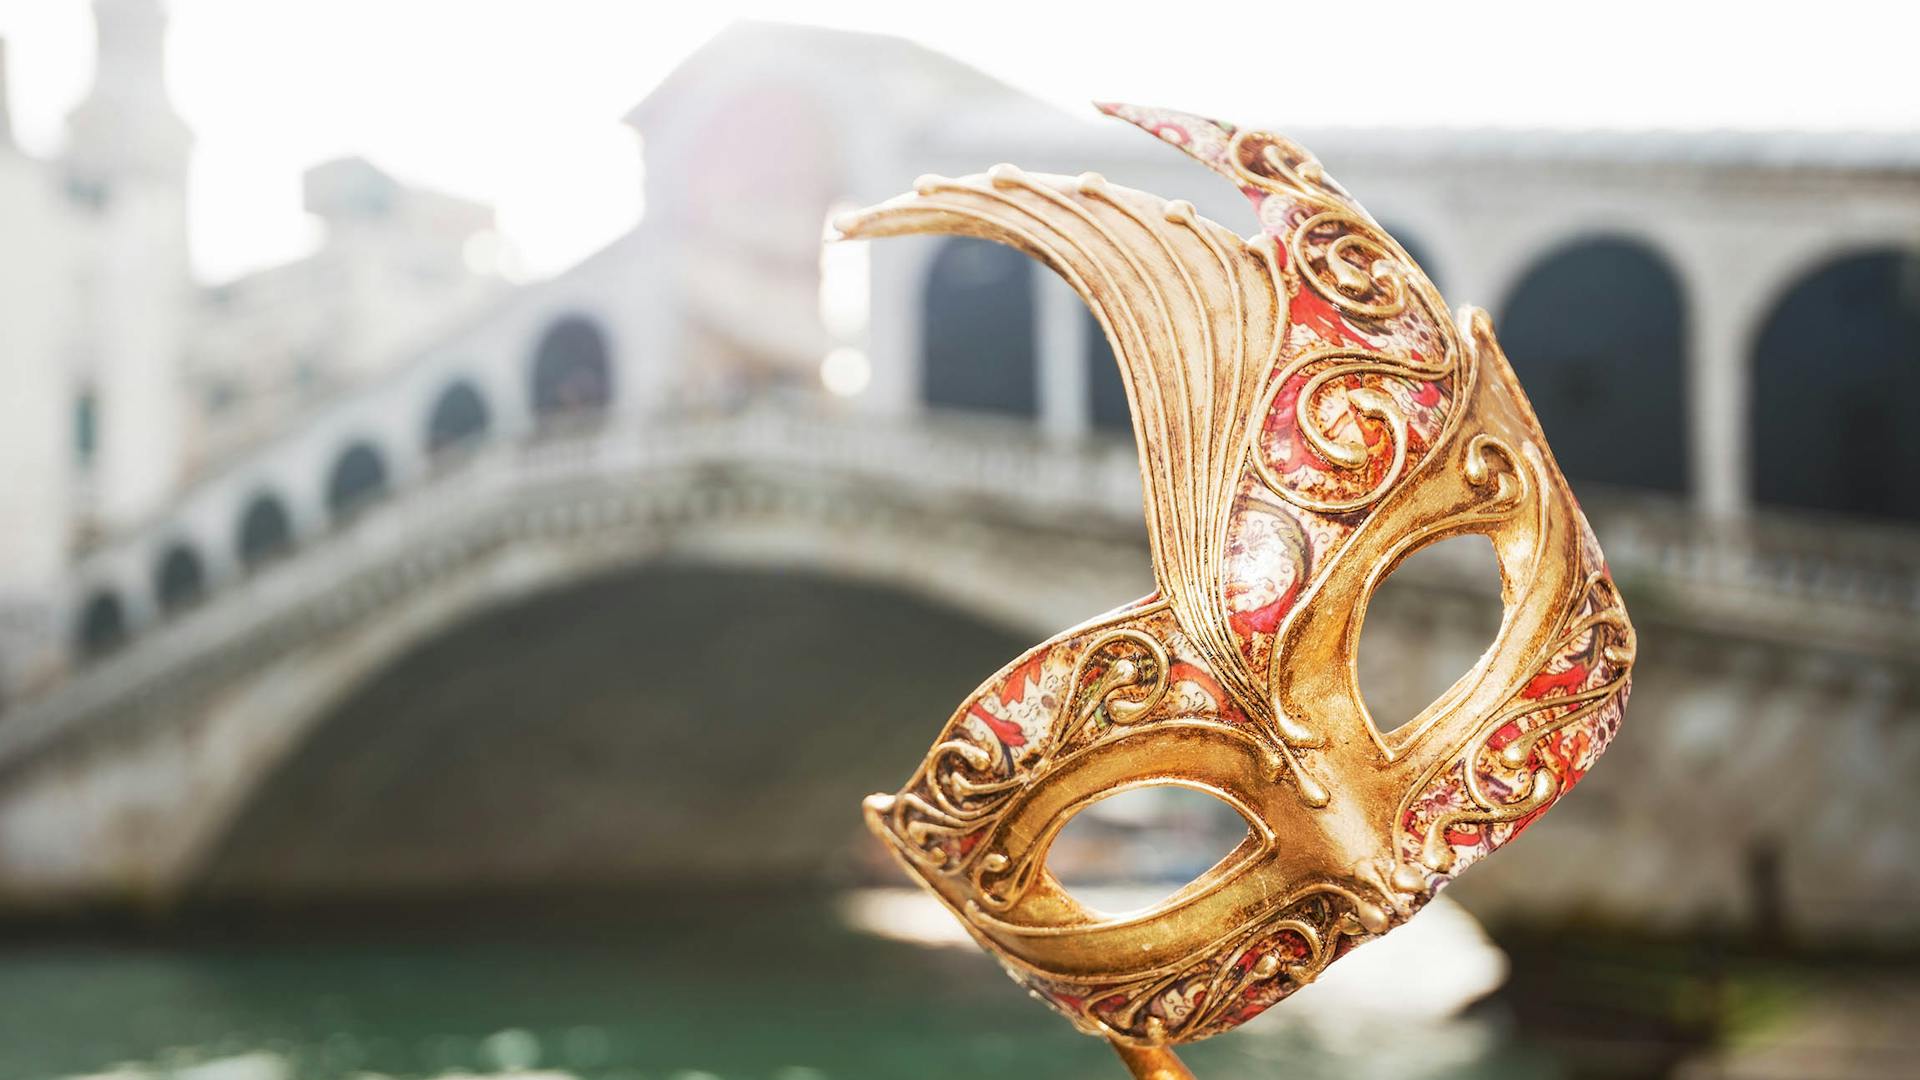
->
<box><xmin>0</xmin><ymin>397</ymin><xmax>1920</xmax><ymax>928</ymax></box>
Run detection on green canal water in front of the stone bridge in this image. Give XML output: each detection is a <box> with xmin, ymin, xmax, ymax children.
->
<box><xmin>0</xmin><ymin>897</ymin><xmax>1563</xmax><ymax>1080</ymax></box>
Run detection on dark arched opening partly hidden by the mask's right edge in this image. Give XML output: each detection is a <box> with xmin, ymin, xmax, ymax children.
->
<box><xmin>1500</xmin><ymin>238</ymin><xmax>1688</xmax><ymax>492</ymax></box>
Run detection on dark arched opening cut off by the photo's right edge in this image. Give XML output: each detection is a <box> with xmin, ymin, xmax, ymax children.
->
<box><xmin>1751</xmin><ymin>250</ymin><xmax>1920</xmax><ymax>521</ymax></box>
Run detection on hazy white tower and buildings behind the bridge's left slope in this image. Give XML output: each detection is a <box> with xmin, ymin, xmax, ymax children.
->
<box><xmin>0</xmin><ymin>0</ymin><xmax>501</xmax><ymax>680</ymax></box>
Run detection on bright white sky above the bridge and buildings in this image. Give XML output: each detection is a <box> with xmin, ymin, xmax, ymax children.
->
<box><xmin>0</xmin><ymin>0</ymin><xmax>1920</xmax><ymax>281</ymax></box>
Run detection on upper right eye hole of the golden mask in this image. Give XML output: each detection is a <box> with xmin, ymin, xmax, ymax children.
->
<box><xmin>1357</xmin><ymin>536</ymin><xmax>1505</xmax><ymax>736</ymax></box>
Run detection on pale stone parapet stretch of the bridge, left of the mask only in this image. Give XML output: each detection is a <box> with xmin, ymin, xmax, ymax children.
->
<box><xmin>0</xmin><ymin>409</ymin><xmax>1144</xmax><ymax>767</ymax></box>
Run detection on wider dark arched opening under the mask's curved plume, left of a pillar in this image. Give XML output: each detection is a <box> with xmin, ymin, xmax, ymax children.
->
<box><xmin>920</xmin><ymin>236</ymin><xmax>1039</xmax><ymax>417</ymax></box>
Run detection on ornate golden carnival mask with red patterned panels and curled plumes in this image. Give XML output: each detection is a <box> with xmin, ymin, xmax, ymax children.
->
<box><xmin>837</xmin><ymin>106</ymin><xmax>1634</xmax><ymax>1078</ymax></box>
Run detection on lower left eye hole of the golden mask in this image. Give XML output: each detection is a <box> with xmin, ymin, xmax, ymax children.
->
<box><xmin>1046</xmin><ymin>784</ymin><xmax>1252</xmax><ymax>915</ymax></box>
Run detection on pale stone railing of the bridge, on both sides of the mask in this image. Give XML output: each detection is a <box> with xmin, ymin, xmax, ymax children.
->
<box><xmin>18</xmin><ymin>407</ymin><xmax>1920</xmax><ymax>737</ymax></box>
